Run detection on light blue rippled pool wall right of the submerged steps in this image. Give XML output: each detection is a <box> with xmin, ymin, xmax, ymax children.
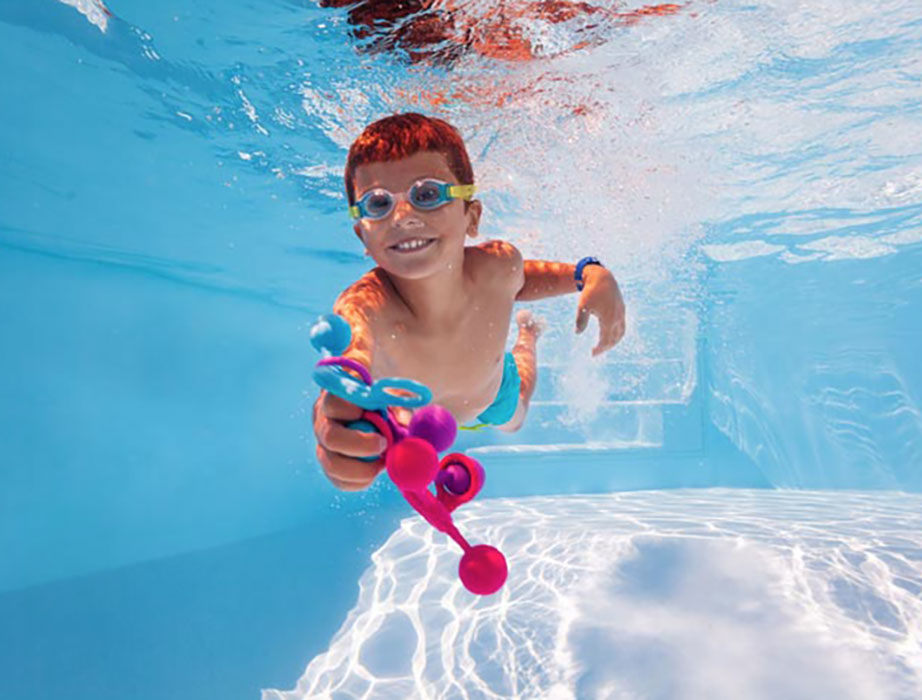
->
<box><xmin>706</xmin><ymin>245</ymin><xmax>922</xmax><ymax>492</ymax></box>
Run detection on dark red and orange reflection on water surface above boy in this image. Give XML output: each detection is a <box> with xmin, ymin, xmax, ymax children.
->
<box><xmin>320</xmin><ymin>0</ymin><xmax>682</xmax><ymax>62</ymax></box>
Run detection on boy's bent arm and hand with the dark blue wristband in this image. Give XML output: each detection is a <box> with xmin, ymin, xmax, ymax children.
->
<box><xmin>516</xmin><ymin>260</ymin><xmax>625</xmax><ymax>355</ymax></box>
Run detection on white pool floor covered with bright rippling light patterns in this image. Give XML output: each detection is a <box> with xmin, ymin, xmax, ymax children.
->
<box><xmin>263</xmin><ymin>490</ymin><xmax>922</xmax><ymax>700</ymax></box>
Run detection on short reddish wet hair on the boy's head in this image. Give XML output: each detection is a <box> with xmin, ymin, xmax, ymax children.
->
<box><xmin>346</xmin><ymin>112</ymin><xmax>474</xmax><ymax>208</ymax></box>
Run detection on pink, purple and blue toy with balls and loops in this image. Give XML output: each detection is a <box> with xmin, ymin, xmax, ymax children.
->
<box><xmin>311</xmin><ymin>314</ymin><xmax>508</xmax><ymax>595</ymax></box>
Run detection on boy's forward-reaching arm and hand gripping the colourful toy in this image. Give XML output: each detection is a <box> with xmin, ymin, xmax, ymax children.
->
<box><xmin>314</xmin><ymin>276</ymin><xmax>386</xmax><ymax>491</ymax></box>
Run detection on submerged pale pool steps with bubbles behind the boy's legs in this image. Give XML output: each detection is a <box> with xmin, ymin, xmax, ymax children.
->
<box><xmin>460</xmin><ymin>304</ymin><xmax>698</xmax><ymax>454</ymax></box>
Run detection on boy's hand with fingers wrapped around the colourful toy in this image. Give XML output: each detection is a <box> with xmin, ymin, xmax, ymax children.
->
<box><xmin>314</xmin><ymin>391</ymin><xmax>387</xmax><ymax>491</ymax></box>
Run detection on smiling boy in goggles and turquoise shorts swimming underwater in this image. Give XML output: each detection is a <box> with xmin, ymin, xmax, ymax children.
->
<box><xmin>314</xmin><ymin>113</ymin><xmax>624</xmax><ymax>491</ymax></box>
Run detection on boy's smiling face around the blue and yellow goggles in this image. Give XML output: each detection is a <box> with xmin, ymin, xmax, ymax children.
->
<box><xmin>355</xmin><ymin>151</ymin><xmax>481</xmax><ymax>279</ymax></box>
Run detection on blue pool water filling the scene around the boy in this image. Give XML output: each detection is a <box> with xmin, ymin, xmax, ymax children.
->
<box><xmin>0</xmin><ymin>0</ymin><xmax>922</xmax><ymax>700</ymax></box>
